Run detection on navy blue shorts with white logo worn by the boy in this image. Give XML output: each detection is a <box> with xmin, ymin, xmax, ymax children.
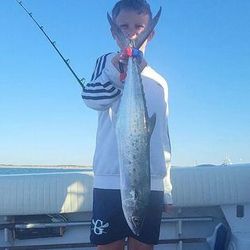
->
<box><xmin>90</xmin><ymin>188</ymin><xmax>163</xmax><ymax>245</ymax></box>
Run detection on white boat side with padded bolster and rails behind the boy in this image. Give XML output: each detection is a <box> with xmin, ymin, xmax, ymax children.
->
<box><xmin>0</xmin><ymin>164</ymin><xmax>250</xmax><ymax>250</ymax></box>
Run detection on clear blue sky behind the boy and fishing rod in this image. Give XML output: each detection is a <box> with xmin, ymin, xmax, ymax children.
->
<box><xmin>0</xmin><ymin>0</ymin><xmax>250</xmax><ymax>166</ymax></box>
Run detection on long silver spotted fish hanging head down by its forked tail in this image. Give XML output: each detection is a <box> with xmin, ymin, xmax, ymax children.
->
<box><xmin>108</xmin><ymin>9</ymin><xmax>161</xmax><ymax>235</ymax></box>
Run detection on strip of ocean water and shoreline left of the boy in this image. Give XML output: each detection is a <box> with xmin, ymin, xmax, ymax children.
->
<box><xmin>0</xmin><ymin>165</ymin><xmax>92</xmax><ymax>175</ymax></box>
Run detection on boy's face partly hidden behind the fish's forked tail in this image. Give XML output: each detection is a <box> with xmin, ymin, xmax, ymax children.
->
<box><xmin>113</xmin><ymin>10</ymin><xmax>153</xmax><ymax>51</ymax></box>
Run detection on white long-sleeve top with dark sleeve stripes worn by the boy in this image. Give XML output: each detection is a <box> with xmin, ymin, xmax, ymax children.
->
<box><xmin>82</xmin><ymin>53</ymin><xmax>172</xmax><ymax>204</ymax></box>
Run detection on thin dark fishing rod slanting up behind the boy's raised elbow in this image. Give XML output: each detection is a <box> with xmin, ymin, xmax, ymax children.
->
<box><xmin>16</xmin><ymin>0</ymin><xmax>85</xmax><ymax>88</ymax></box>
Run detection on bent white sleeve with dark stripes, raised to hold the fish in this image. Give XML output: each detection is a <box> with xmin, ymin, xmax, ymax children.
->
<box><xmin>82</xmin><ymin>53</ymin><xmax>122</xmax><ymax>111</ymax></box>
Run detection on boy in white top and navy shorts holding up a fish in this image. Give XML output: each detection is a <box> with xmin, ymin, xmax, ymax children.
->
<box><xmin>82</xmin><ymin>0</ymin><xmax>172</xmax><ymax>250</ymax></box>
